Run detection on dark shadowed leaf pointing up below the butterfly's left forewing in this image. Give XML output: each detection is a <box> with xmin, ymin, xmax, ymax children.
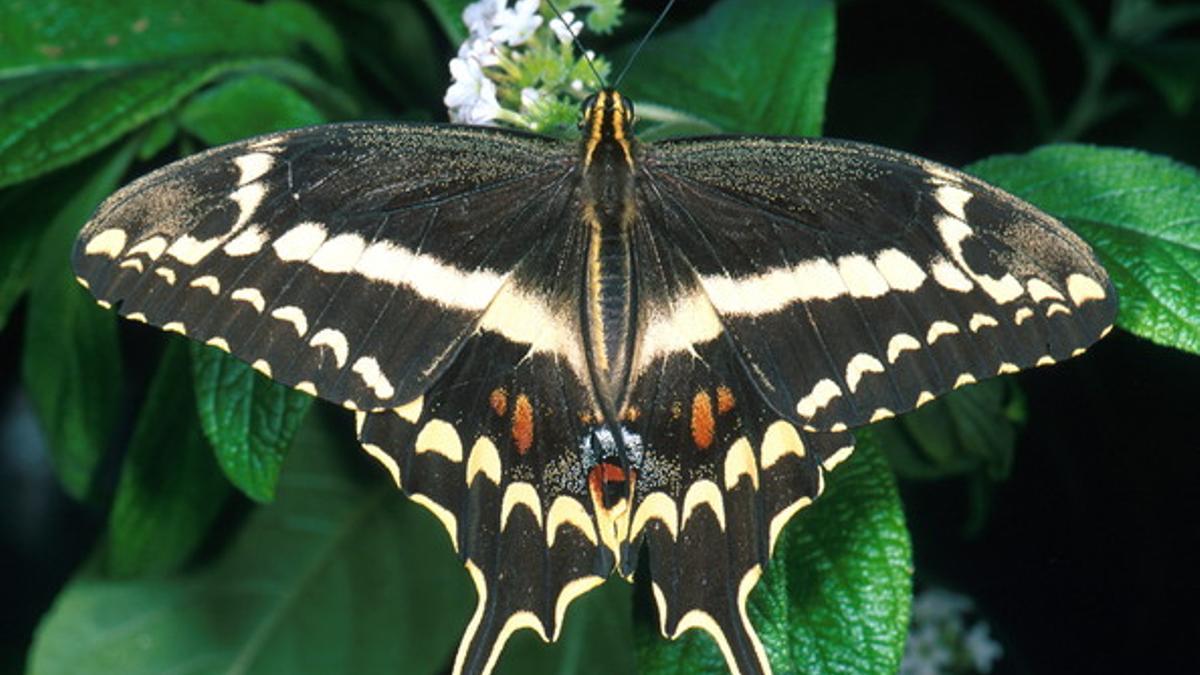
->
<box><xmin>102</xmin><ymin>339</ymin><xmax>230</xmax><ymax>577</ymax></box>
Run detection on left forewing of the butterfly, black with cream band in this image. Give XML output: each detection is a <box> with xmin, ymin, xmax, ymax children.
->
<box><xmin>74</xmin><ymin>124</ymin><xmax>572</xmax><ymax>410</ymax></box>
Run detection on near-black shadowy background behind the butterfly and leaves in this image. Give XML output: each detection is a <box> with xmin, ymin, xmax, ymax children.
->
<box><xmin>0</xmin><ymin>0</ymin><xmax>1200</xmax><ymax>673</ymax></box>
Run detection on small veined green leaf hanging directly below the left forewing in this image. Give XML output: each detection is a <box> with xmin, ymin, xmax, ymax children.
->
<box><xmin>192</xmin><ymin>342</ymin><xmax>312</xmax><ymax>502</ymax></box>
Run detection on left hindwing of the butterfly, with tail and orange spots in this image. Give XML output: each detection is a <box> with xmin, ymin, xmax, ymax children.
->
<box><xmin>359</xmin><ymin>211</ymin><xmax>614</xmax><ymax>674</ymax></box>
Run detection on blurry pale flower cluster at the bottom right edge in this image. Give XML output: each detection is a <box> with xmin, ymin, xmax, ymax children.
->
<box><xmin>900</xmin><ymin>589</ymin><xmax>1004</xmax><ymax>675</ymax></box>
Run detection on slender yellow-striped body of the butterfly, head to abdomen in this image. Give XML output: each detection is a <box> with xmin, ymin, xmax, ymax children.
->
<box><xmin>580</xmin><ymin>91</ymin><xmax>637</xmax><ymax>419</ymax></box>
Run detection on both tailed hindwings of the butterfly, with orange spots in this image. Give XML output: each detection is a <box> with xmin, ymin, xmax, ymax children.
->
<box><xmin>359</xmin><ymin>200</ymin><xmax>852</xmax><ymax>675</ymax></box>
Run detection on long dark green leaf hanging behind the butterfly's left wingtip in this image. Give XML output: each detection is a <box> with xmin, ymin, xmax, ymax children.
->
<box><xmin>22</xmin><ymin>144</ymin><xmax>136</xmax><ymax>500</ymax></box>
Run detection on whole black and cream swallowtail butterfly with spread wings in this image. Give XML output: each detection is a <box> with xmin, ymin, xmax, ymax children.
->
<box><xmin>74</xmin><ymin>90</ymin><xmax>1116</xmax><ymax>674</ymax></box>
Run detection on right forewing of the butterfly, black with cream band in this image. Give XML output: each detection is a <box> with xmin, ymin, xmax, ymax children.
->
<box><xmin>642</xmin><ymin>137</ymin><xmax>1116</xmax><ymax>431</ymax></box>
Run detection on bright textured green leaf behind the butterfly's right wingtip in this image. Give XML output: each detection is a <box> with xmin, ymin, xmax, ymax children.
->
<box><xmin>967</xmin><ymin>145</ymin><xmax>1200</xmax><ymax>353</ymax></box>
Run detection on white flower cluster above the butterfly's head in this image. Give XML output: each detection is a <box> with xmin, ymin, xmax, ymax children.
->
<box><xmin>444</xmin><ymin>0</ymin><xmax>620</xmax><ymax>131</ymax></box>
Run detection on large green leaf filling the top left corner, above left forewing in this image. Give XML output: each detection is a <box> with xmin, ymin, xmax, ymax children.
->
<box><xmin>0</xmin><ymin>0</ymin><xmax>337</xmax><ymax>185</ymax></box>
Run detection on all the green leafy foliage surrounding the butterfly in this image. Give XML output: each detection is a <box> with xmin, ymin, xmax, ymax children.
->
<box><xmin>0</xmin><ymin>0</ymin><xmax>1200</xmax><ymax>674</ymax></box>
